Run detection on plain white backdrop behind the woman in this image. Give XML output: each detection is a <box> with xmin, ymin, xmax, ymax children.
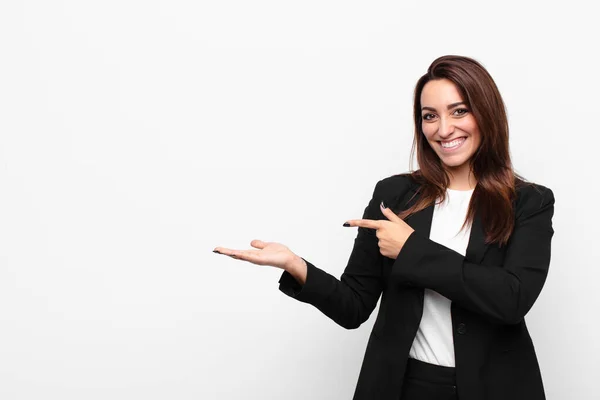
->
<box><xmin>0</xmin><ymin>0</ymin><xmax>600</xmax><ymax>400</ymax></box>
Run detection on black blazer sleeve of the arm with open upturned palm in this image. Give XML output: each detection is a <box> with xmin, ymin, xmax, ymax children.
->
<box><xmin>279</xmin><ymin>181</ymin><xmax>392</xmax><ymax>329</ymax></box>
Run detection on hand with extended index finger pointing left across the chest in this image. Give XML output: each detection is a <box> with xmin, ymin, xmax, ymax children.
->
<box><xmin>344</xmin><ymin>202</ymin><xmax>415</xmax><ymax>259</ymax></box>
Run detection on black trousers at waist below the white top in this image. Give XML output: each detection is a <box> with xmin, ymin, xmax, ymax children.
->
<box><xmin>399</xmin><ymin>358</ymin><xmax>458</xmax><ymax>400</ymax></box>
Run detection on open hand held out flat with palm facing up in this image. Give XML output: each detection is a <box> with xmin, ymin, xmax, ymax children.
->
<box><xmin>213</xmin><ymin>240</ymin><xmax>303</xmax><ymax>270</ymax></box>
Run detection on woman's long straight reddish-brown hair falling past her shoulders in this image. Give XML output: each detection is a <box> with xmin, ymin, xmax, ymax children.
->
<box><xmin>399</xmin><ymin>55</ymin><xmax>525</xmax><ymax>245</ymax></box>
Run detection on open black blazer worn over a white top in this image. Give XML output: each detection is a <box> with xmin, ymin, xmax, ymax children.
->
<box><xmin>279</xmin><ymin>174</ymin><xmax>554</xmax><ymax>400</ymax></box>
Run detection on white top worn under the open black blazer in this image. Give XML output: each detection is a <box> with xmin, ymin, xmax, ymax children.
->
<box><xmin>409</xmin><ymin>189</ymin><xmax>474</xmax><ymax>367</ymax></box>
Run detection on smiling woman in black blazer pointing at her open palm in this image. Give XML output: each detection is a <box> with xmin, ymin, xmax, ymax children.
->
<box><xmin>215</xmin><ymin>56</ymin><xmax>554</xmax><ymax>400</ymax></box>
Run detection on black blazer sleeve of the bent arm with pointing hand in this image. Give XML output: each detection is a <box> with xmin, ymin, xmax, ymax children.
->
<box><xmin>391</xmin><ymin>185</ymin><xmax>554</xmax><ymax>324</ymax></box>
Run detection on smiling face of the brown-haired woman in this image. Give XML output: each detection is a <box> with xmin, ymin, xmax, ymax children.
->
<box><xmin>421</xmin><ymin>79</ymin><xmax>481</xmax><ymax>171</ymax></box>
